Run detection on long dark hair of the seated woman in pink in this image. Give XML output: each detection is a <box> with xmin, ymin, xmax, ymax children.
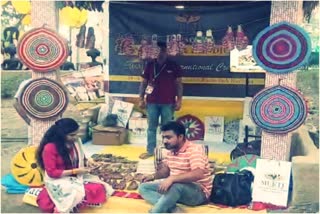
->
<box><xmin>36</xmin><ymin>118</ymin><xmax>79</xmax><ymax>170</ymax></box>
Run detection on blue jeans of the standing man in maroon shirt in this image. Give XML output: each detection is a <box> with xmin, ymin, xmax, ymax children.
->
<box><xmin>147</xmin><ymin>104</ymin><xmax>174</xmax><ymax>154</ymax></box>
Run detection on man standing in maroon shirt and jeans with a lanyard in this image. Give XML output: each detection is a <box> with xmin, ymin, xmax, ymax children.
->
<box><xmin>139</xmin><ymin>42</ymin><xmax>183</xmax><ymax>159</ymax></box>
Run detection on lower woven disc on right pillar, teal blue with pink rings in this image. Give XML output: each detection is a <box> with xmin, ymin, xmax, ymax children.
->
<box><xmin>250</xmin><ymin>86</ymin><xmax>307</xmax><ymax>133</ymax></box>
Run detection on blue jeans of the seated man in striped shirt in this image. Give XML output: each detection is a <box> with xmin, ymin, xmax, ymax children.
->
<box><xmin>139</xmin><ymin>181</ymin><xmax>207</xmax><ymax>213</ymax></box>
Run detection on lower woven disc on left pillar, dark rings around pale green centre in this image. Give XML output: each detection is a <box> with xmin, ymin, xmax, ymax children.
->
<box><xmin>19</xmin><ymin>78</ymin><xmax>68</xmax><ymax>119</ymax></box>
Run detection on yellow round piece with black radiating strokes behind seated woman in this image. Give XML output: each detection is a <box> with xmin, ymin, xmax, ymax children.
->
<box><xmin>11</xmin><ymin>146</ymin><xmax>43</xmax><ymax>186</ymax></box>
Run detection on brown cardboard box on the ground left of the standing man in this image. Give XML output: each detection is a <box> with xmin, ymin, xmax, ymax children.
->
<box><xmin>92</xmin><ymin>125</ymin><xmax>128</xmax><ymax>145</ymax></box>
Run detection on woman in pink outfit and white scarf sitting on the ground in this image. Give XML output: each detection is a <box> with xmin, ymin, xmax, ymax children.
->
<box><xmin>36</xmin><ymin>118</ymin><xmax>112</xmax><ymax>213</ymax></box>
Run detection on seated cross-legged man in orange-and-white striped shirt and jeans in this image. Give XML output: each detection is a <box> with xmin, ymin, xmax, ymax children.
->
<box><xmin>139</xmin><ymin>121</ymin><xmax>212</xmax><ymax>213</ymax></box>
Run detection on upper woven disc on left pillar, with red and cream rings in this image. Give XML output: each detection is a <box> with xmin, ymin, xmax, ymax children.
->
<box><xmin>18</xmin><ymin>28</ymin><xmax>69</xmax><ymax>72</ymax></box>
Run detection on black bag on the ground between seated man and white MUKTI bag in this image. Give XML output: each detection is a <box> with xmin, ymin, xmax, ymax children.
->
<box><xmin>210</xmin><ymin>170</ymin><xmax>254</xmax><ymax>207</ymax></box>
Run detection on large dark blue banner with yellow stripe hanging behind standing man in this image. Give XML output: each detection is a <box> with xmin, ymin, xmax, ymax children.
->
<box><xmin>109</xmin><ymin>2</ymin><xmax>271</xmax><ymax>98</ymax></box>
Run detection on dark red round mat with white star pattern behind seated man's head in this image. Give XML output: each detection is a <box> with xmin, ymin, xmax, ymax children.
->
<box><xmin>177</xmin><ymin>114</ymin><xmax>204</xmax><ymax>140</ymax></box>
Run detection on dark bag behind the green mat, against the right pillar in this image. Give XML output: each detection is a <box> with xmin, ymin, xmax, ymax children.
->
<box><xmin>230</xmin><ymin>140</ymin><xmax>261</xmax><ymax>160</ymax></box>
